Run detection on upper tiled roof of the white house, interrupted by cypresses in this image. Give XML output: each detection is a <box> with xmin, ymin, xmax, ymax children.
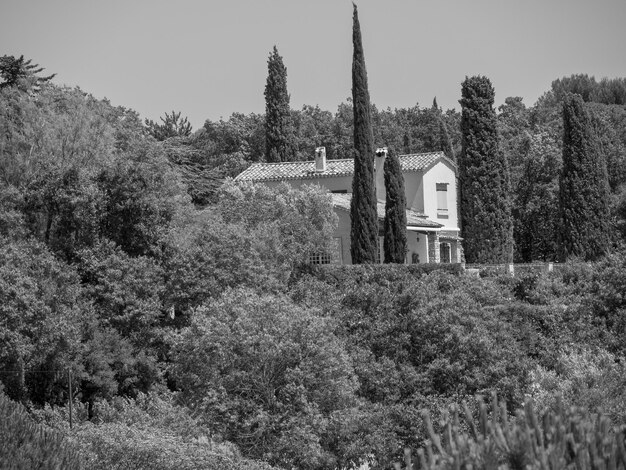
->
<box><xmin>235</xmin><ymin>152</ymin><xmax>456</xmax><ymax>182</ymax></box>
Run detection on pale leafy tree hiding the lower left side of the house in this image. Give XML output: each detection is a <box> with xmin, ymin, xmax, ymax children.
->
<box><xmin>164</xmin><ymin>181</ymin><xmax>337</xmax><ymax>313</ymax></box>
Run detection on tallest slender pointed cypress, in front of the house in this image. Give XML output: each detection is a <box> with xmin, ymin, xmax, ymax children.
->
<box><xmin>350</xmin><ymin>4</ymin><xmax>378</xmax><ymax>264</ymax></box>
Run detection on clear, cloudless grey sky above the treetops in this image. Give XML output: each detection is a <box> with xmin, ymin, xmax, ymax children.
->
<box><xmin>0</xmin><ymin>0</ymin><xmax>626</xmax><ymax>128</ymax></box>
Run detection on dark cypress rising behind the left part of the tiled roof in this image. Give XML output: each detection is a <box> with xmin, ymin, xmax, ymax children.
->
<box><xmin>265</xmin><ymin>46</ymin><xmax>294</xmax><ymax>162</ymax></box>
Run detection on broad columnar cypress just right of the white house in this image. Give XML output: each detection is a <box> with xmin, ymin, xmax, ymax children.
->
<box><xmin>459</xmin><ymin>76</ymin><xmax>513</xmax><ymax>263</ymax></box>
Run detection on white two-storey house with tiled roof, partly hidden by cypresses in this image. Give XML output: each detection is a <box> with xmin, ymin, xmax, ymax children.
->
<box><xmin>235</xmin><ymin>147</ymin><xmax>461</xmax><ymax>264</ymax></box>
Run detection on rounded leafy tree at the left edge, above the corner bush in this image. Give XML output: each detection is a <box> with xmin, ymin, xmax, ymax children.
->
<box><xmin>0</xmin><ymin>239</ymin><xmax>86</xmax><ymax>403</ymax></box>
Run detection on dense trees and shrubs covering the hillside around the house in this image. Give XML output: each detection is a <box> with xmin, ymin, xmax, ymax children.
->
<box><xmin>0</xmin><ymin>63</ymin><xmax>626</xmax><ymax>469</ymax></box>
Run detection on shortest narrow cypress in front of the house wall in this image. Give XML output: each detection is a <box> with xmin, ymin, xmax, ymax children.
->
<box><xmin>383</xmin><ymin>150</ymin><xmax>406</xmax><ymax>263</ymax></box>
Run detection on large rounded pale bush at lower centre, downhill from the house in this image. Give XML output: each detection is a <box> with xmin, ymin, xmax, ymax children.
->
<box><xmin>172</xmin><ymin>289</ymin><xmax>356</xmax><ymax>468</ymax></box>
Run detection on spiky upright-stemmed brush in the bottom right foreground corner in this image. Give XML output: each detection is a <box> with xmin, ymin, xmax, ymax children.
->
<box><xmin>394</xmin><ymin>395</ymin><xmax>626</xmax><ymax>470</ymax></box>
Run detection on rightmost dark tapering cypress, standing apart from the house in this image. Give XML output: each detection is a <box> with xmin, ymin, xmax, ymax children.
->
<box><xmin>558</xmin><ymin>94</ymin><xmax>609</xmax><ymax>261</ymax></box>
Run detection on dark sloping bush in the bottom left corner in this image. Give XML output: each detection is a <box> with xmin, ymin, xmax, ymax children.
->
<box><xmin>0</xmin><ymin>392</ymin><xmax>82</xmax><ymax>470</ymax></box>
